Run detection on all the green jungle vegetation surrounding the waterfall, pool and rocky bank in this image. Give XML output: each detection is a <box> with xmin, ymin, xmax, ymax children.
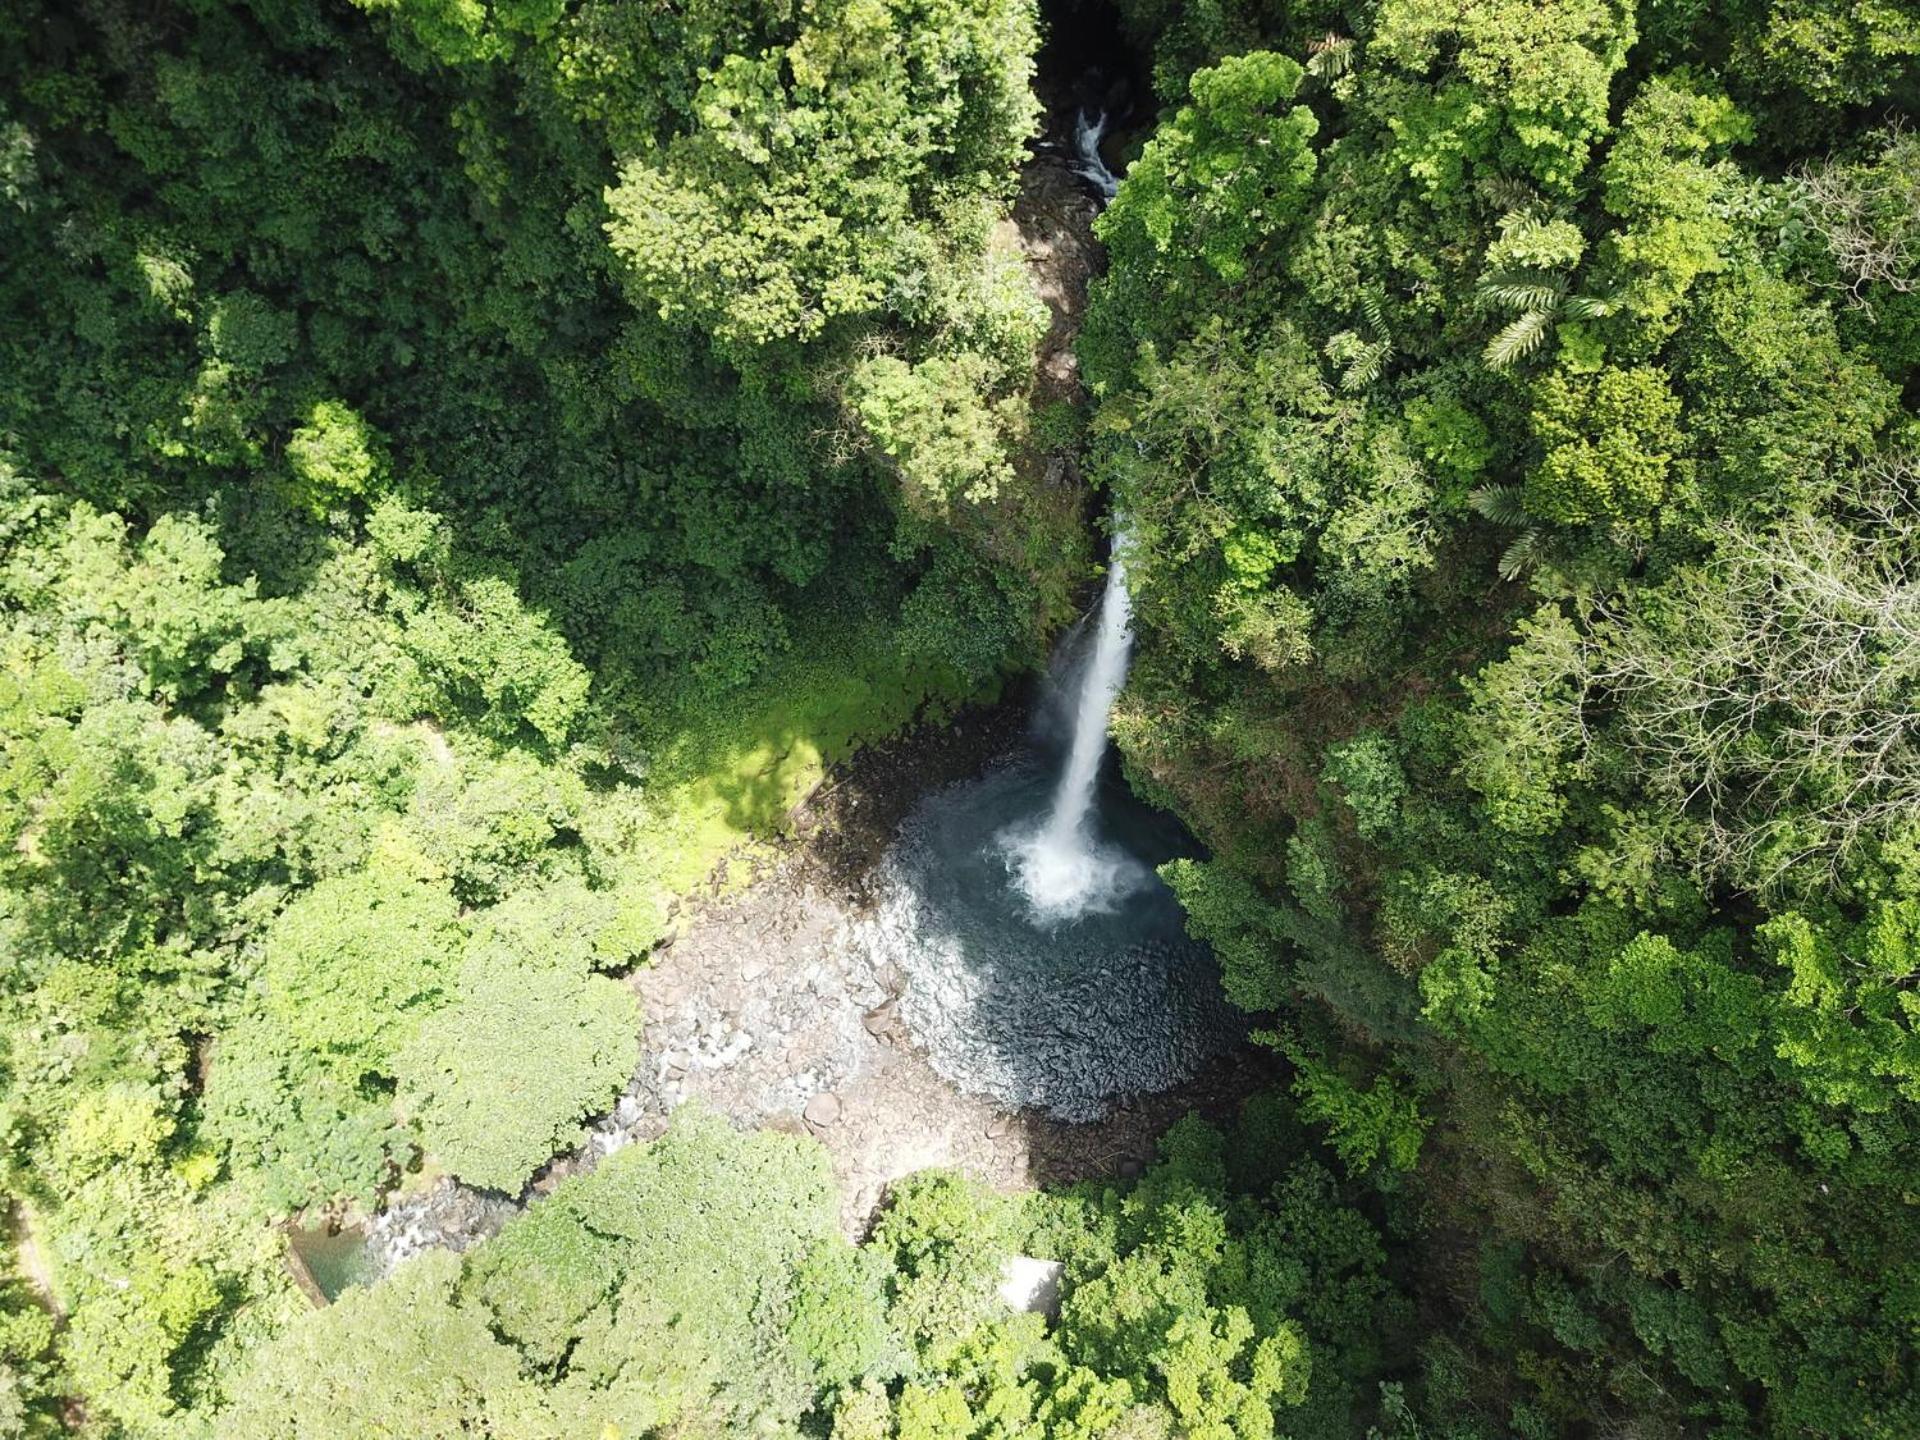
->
<box><xmin>0</xmin><ymin>0</ymin><xmax>1920</xmax><ymax>1440</ymax></box>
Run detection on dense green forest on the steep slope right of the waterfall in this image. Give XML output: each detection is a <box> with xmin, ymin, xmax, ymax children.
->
<box><xmin>1083</xmin><ymin>0</ymin><xmax>1920</xmax><ymax>1436</ymax></box>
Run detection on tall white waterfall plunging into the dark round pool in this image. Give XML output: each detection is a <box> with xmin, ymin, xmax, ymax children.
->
<box><xmin>1002</xmin><ymin>534</ymin><xmax>1148</xmax><ymax>924</ymax></box>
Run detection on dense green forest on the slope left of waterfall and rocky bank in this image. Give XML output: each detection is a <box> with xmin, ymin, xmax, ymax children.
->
<box><xmin>0</xmin><ymin>0</ymin><xmax>1085</xmax><ymax>1434</ymax></box>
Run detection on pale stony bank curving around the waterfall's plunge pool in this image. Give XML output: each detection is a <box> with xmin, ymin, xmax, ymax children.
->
<box><xmin>361</xmin><ymin>699</ymin><xmax>1265</xmax><ymax>1275</ymax></box>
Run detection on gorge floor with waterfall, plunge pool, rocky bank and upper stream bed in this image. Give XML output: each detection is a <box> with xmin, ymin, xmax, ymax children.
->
<box><xmin>318</xmin><ymin>71</ymin><xmax>1244</xmax><ymax>1298</ymax></box>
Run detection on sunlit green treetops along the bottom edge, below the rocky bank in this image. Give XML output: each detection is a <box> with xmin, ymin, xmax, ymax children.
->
<box><xmin>217</xmin><ymin>1104</ymin><xmax>1405</xmax><ymax>1440</ymax></box>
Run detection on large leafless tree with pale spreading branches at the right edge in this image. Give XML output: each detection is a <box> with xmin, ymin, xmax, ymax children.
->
<box><xmin>1580</xmin><ymin>459</ymin><xmax>1920</xmax><ymax>889</ymax></box>
